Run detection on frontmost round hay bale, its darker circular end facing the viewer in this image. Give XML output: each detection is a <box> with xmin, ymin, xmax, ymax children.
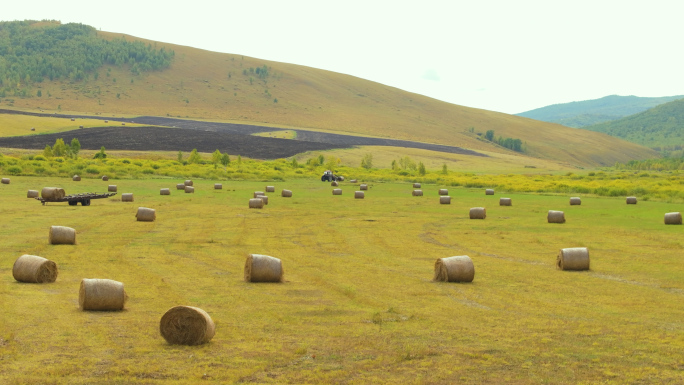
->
<box><xmin>159</xmin><ymin>306</ymin><xmax>216</xmax><ymax>346</ymax></box>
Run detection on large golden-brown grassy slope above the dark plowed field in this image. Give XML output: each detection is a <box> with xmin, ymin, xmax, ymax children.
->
<box><xmin>2</xmin><ymin>21</ymin><xmax>657</xmax><ymax>166</ymax></box>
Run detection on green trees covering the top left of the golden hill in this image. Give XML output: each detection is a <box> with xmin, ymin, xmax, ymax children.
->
<box><xmin>0</xmin><ymin>20</ymin><xmax>175</xmax><ymax>97</ymax></box>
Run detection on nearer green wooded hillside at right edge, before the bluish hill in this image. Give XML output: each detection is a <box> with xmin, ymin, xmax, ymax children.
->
<box><xmin>586</xmin><ymin>99</ymin><xmax>684</xmax><ymax>151</ymax></box>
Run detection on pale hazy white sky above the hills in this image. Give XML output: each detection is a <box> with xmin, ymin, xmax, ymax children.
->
<box><xmin>0</xmin><ymin>0</ymin><xmax>684</xmax><ymax>113</ymax></box>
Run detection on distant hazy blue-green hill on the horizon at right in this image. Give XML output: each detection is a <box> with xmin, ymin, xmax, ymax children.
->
<box><xmin>516</xmin><ymin>95</ymin><xmax>684</xmax><ymax>128</ymax></box>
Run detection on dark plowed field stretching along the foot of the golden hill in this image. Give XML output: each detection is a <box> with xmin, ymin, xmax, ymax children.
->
<box><xmin>0</xmin><ymin>110</ymin><xmax>486</xmax><ymax>159</ymax></box>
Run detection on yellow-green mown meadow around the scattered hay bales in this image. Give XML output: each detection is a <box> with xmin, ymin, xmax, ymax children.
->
<box><xmin>0</xmin><ymin>175</ymin><xmax>684</xmax><ymax>384</ymax></box>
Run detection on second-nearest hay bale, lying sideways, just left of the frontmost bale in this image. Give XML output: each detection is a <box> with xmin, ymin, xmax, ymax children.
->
<box><xmin>78</xmin><ymin>278</ymin><xmax>128</xmax><ymax>310</ymax></box>
